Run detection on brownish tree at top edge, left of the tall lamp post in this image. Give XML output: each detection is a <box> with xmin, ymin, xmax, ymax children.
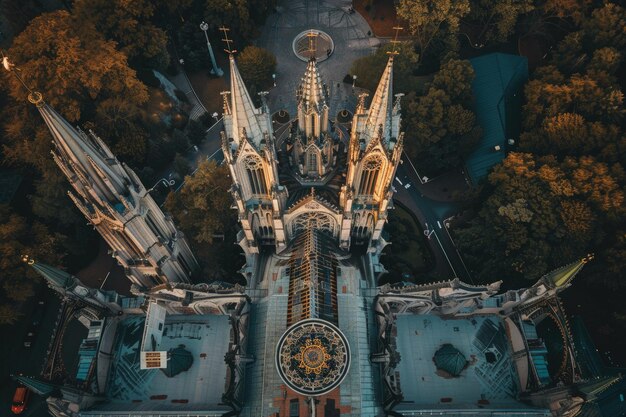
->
<box><xmin>72</xmin><ymin>0</ymin><xmax>169</xmax><ymax>68</ymax></box>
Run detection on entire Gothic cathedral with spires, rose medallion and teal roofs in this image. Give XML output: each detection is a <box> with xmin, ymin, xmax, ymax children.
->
<box><xmin>8</xmin><ymin>44</ymin><xmax>618</xmax><ymax>417</ymax></box>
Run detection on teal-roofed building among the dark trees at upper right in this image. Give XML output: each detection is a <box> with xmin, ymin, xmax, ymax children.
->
<box><xmin>465</xmin><ymin>53</ymin><xmax>528</xmax><ymax>184</ymax></box>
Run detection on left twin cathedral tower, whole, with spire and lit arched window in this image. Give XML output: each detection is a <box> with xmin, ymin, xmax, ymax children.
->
<box><xmin>222</xmin><ymin>53</ymin><xmax>287</xmax><ymax>256</ymax></box>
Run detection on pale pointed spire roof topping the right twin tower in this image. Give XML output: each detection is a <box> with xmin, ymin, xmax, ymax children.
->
<box><xmin>363</xmin><ymin>55</ymin><xmax>393</xmax><ymax>142</ymax></box>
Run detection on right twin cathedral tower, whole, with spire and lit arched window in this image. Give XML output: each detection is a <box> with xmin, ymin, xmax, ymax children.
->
<box><xmin>340</xmin><ymin>54</ymin><xmax>403</xmax><ymax>251</ymax></box>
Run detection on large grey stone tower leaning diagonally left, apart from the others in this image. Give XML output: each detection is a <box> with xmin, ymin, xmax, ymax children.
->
<box><xmin>29</xmin><ymin>92</ymin><xmax>198</xmax><ymax>288</ymax></box>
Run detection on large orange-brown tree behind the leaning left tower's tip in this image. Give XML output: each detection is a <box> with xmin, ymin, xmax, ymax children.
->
<box><xmin>8</xmin><ymin>10</ymin><xmax>148</xmax><ymax>122</ymax></box>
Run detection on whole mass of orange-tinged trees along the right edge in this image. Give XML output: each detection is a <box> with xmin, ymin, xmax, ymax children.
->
<box><xmin>456</xmin><ymin>1</ymin><xmax>626</xmax><ymax>288</ymax></box>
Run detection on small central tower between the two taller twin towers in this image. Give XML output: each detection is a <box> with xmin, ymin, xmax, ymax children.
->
<box><xmin>290</xmin><ymin>58</ymin><xmax>335</xmax><ymax>183</ymax></box>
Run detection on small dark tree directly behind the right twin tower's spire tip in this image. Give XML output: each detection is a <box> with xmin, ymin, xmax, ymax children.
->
<box><xmin>350</xmin><ymin>42</ymin><xmax>418</xmax><ymax>93</ymax></box>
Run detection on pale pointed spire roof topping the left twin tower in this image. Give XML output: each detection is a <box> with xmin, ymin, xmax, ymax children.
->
<box><xmin>229</xmin><ymin>54</ymin><xmax>263</xmax><ymax>146</ymax></box>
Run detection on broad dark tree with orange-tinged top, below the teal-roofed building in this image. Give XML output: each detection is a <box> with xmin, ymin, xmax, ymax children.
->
<box><xmin>450</xmin><ymin>153</ymin><xmax>624</xmax><ymax>280</ymax></box>
